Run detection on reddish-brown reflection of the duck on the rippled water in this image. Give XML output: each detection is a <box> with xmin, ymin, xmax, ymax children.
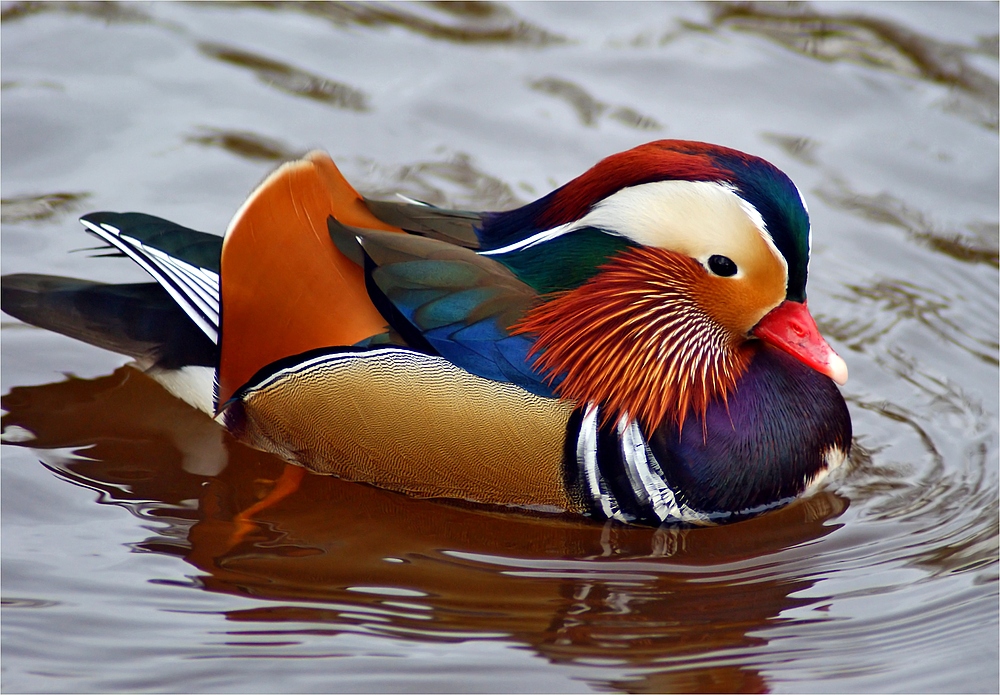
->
<box><xmin>2</xmin><ymin>367</ymin><xmax>847</xmax><ymax>692</ymax></box>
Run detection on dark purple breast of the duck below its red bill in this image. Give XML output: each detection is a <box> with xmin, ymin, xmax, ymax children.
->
<box><xmin>646</xmin><ymin>340</ymin><xmax>851</xmax><ymax>515</ymax></box>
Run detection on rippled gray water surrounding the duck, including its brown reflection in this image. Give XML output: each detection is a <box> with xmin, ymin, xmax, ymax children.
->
<box><xmin>0</xmin><ymin>3</ymin><xmax>1000</xmax><ymax>692</ymax></box>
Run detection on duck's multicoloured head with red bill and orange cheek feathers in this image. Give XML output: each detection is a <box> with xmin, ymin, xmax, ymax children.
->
<box><xmin>480</xmin><ymin>140</ymin><xmax>847</xmax><ymax>428</ymax></box>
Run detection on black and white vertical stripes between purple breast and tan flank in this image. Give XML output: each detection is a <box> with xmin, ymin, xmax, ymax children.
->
<box><xmin>566</xmin><ymin>404</ymin><xmax>714</xmax><ymax>525</ymax></box>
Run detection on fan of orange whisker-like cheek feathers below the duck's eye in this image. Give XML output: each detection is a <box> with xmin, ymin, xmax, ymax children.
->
<box><xmin>513</xmin><ymin>248</ymin><xmax>746</xmax><ymax>429</ymax></box>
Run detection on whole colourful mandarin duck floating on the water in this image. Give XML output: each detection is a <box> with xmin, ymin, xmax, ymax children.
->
<box><xmin>3</xmin><ymin>140</ymin><xmax>851</xmax><ymax>525</ymax></box>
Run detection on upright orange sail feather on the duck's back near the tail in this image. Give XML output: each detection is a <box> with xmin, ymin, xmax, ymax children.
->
<box><xmin>218</xmin><ymin>152</ymin><xmax>401</xmax><ymax>404</ymax></box>
